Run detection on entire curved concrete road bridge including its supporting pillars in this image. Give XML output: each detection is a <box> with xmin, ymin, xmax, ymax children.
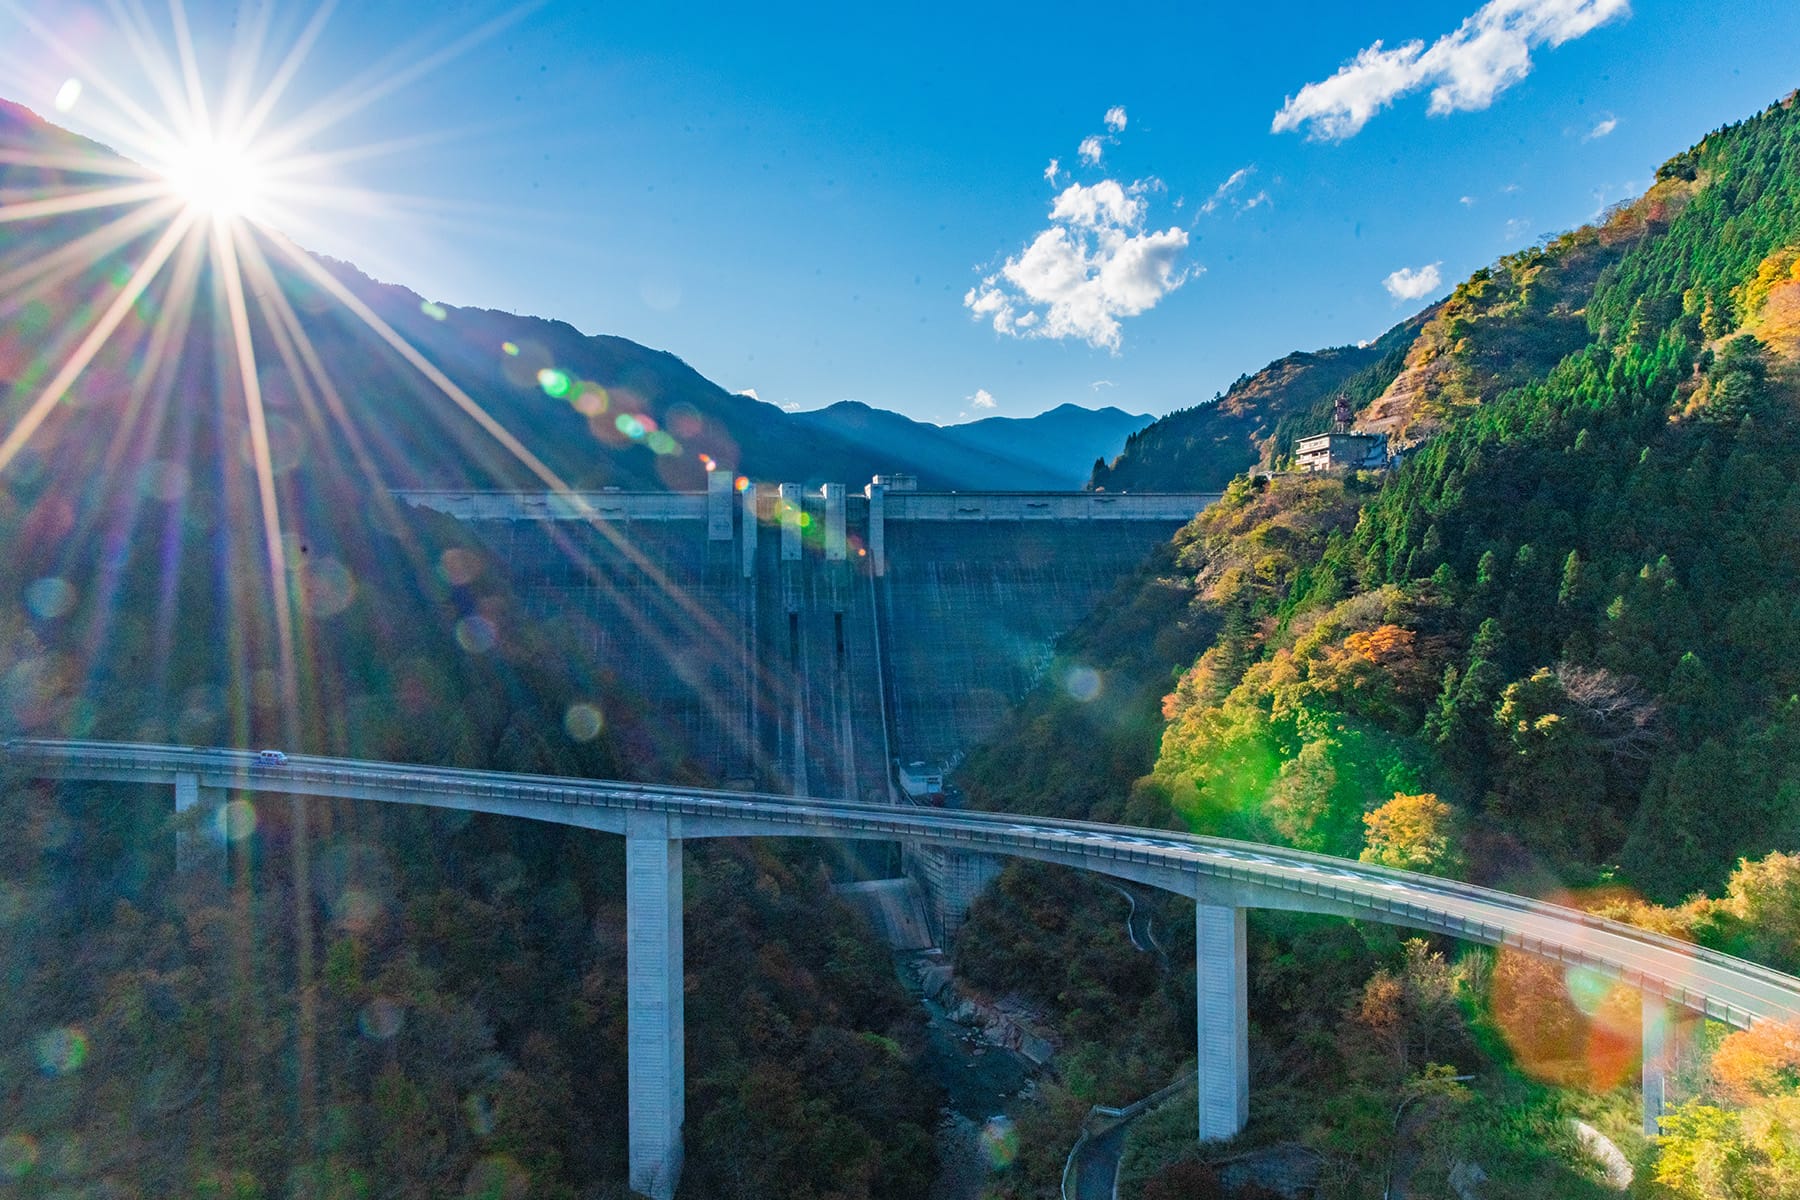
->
<box><xmin>4</xmin><ymin>741</ymin><xmax>1800</xmax><ymax>1200</ymax></box>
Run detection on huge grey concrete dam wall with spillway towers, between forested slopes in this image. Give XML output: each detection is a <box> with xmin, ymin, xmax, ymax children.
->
<box><xmin>398</xmin><ymin>473</ymin><xmax>1217</xmax><ymax>802</ymax></box>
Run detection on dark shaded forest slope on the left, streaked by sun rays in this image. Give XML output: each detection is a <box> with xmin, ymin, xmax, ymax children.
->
<box><xmin>0</xmin><ymin>103</ymin><xmax>938</xmax><ymax>1200</ymax></box>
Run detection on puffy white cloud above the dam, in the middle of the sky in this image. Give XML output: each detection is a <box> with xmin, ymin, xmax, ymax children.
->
<box><xmin>963</xmin><ymin>180</ymin><xmax>1197</xmax><ymax>353</ymax></box>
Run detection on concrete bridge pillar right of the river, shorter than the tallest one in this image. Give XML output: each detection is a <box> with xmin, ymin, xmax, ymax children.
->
<box><xmin>1193</xmin><ymin>903</ymin><xmax>1249</xmax><ymax>1142</ymax></box>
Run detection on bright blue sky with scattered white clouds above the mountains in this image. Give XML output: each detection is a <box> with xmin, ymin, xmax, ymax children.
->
<box><xmin>0</xmin><ymin>0</ymin><xmax>1800</xmax><ymax>421</ymax></box>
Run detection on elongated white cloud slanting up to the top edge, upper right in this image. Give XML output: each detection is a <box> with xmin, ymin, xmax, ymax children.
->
<box><xmin>1271</xmin><ymin>0</ymin><xmax>1631</xmax><ymax>142</ymax></box>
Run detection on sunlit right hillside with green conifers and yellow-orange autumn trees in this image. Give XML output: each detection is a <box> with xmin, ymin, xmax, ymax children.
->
<box><xmin>965</xmin><ymin>89</ymin><xmax>1800</xmax><ymax>1200</ymax></box>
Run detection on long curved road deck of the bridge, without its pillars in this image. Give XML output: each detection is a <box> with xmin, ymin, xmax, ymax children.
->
<box><xmin>4</xmin><ymin>739</ymin><xmax>1800</xmax><ymax>1027</ymax></box>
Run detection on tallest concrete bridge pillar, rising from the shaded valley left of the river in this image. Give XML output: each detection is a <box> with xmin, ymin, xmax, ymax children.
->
<box><xmin>625</xmin><ymin>813</ymin><xmax>688</xmax><ymax>1200</ymax></box>
